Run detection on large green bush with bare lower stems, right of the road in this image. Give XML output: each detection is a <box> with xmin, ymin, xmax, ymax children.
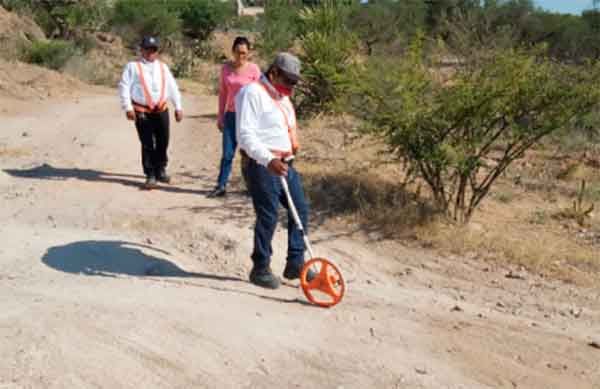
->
<box><xmin>351</xmin><ymin>43</ymin><xmax>600</xmax><ymax>222</ymax></box>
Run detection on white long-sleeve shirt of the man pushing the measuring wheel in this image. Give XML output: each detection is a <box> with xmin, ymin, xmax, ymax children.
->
<box><xmin>235</xmin><ymin>76</ymin><xmax>296</xmax><ymax>166</ymax></box>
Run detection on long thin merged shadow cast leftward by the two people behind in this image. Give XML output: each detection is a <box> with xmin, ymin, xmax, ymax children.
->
<box><xmin>4</xmin><ymin>163</ymin><xmax>208</xmax><ymax>194</ymax></box>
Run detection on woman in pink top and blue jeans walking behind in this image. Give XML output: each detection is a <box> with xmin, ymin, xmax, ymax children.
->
<box><xmin>208</xmin><ymin>36</ymin><xmax>261</xmax><ymax>197</ymax></box>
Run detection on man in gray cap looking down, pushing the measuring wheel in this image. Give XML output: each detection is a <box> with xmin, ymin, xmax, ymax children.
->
<box><xmin>235</xmin><ymin>53</ymin><xmax>313</xmax><ymax>289</ymax></box>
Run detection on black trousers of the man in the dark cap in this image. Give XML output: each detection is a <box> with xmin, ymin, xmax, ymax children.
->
<box><xmin>135</xmin><ymin>110</ymin><xmax>169</xmax><ymax>177</ymax></box>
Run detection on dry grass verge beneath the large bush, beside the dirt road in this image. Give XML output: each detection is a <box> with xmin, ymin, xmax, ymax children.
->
<box><xmin>299</xmin><ymin>117</ymin><xmax>600</xmax><ymax>283</ymax></box>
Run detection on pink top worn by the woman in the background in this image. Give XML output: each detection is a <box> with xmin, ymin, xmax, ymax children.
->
<box><xmin>219</xmin><ymin>62</ymin><xmax>261</xmax><ymax>124</ymax></box>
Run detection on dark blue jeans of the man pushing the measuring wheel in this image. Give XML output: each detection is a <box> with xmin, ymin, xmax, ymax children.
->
<box><xmin>248</xmin><ymin>160</ymin><xmax>308</xmax><ymax>268</ymax></box>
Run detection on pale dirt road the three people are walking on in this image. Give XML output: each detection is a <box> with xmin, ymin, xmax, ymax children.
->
<box><xmin>0</xmin><ymin>90</ymin><xmax>600</xmax><ymax>389</ymax></box>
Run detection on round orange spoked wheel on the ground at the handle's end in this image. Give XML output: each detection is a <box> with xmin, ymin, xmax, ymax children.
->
<box><xmin>300</xmin><ymin>258</ymin><xmax>346</xmax><ymax>307</ymax></box>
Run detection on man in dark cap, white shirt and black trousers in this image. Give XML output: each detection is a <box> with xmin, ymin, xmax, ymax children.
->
<box><xmin>119</xmin><ymin>36</ymin><xmax>183</xmax><ymax>189</ymax></box>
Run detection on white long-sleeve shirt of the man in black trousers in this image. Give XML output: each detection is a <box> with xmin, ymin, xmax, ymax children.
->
<box><xmin>119</xmin><ymin>59</ymin><xmax>182</xmax><ymax>111</ymax></box>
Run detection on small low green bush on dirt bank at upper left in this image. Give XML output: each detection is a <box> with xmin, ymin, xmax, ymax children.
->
<box><xmin>22</xmin><ymin>40</ymin><xmax>77</xmax><ymax>70</ymax></box>
